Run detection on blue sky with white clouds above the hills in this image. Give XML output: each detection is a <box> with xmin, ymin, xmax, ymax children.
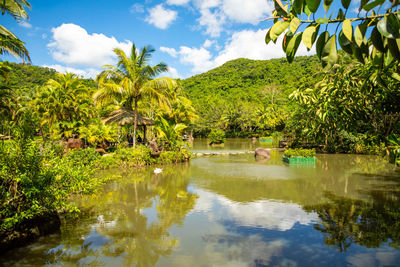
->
<box><xmin>1</xmin><ymin>0</ymin><xmax>370</xmax><ymax>78</ymax></box>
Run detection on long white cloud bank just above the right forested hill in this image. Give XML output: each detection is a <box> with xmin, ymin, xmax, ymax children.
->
<box><xmin>164</xmin><ymin>29</ymin><xmax>315</xmax><ymax>74</ymax></box>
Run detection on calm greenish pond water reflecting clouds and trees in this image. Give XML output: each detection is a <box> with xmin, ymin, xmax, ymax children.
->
<box><xmin>0</xmin><ymin>139</ymin><xmax>400</xmax><ymax>266</ymax></box>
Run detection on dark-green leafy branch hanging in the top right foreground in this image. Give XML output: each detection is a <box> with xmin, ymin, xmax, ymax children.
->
<box><xmin>265</xmin><ymin>0</ymin><xmax>400</xmax><ymax>69</ymax></box>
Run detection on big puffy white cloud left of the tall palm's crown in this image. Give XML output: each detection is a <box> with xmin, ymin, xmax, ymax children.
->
<box><xmin>47</xmin><ymin>24</ymin><xmax>132</xmax><ymax>67</ymax></box>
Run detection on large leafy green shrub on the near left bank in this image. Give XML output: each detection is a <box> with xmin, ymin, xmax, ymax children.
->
<box><xmin>0</xmin><ymin>139</ymin><xmax>104</xmax><ymax>232</ymax></box>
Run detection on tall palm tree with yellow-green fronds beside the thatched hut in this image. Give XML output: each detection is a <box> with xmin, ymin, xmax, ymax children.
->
<box><xmin>93</xmin><ymin>44</ymin><xmax>176</xmax><ymax>147</ymax></box>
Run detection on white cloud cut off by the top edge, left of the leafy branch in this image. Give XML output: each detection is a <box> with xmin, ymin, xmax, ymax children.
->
<box><xmin>222</xmin><ymin>0</ymin><xmax>274</xmax><ymax>24</ymax></box>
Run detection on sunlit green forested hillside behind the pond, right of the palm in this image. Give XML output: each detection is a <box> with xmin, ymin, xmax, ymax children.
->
<box><xmin>182</xmin><ymin>56</ymin><xmax>320</xmax><ymax>136</ymax></box>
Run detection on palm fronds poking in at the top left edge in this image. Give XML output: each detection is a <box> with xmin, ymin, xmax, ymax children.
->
<box><xmin>0</xmin><ymin>0</ymin><xmax>30</xmax><ymax>61</ymax></box>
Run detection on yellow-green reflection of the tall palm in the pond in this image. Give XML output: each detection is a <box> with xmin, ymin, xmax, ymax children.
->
<box><xmin>44</xmin><ymin>168</ymin><xmax>197</xmax><ymax>266</ymax></box>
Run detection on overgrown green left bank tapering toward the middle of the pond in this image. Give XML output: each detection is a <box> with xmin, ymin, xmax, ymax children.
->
<box><xmin>0</xmin><ymin>140</ymin><xmax>191</xmax><ymax>254</ymax></box>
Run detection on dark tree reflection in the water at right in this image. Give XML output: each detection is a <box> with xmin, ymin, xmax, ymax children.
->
<box><xmin>304</xmin><ymin>174</ymin><xmax>400</xmax><ymax>252</ymax></box>
